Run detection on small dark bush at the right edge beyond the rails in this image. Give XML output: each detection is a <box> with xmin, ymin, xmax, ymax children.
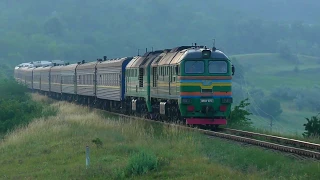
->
<box><xmin>302</xmin><ymin>113</ymin><xmax>320</xmax><ymax>137</ymax></box>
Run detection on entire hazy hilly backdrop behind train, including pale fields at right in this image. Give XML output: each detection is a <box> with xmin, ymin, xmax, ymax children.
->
<box><xmin>0</xmin><ymin>0</ymin><xmax>320</xmax><ymax>134</ymax></box>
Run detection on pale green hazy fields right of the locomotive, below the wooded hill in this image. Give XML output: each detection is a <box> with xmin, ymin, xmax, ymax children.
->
<box><xmin>230</xmin><ymin>53</ymin><xmax>320</xmax><ymax>133</ymax></box>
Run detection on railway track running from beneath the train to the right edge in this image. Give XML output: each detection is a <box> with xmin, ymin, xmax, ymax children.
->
<box><xmin>101</xmin><ymin>110</ymin><xmax>320</xmax><ymax>160</ymax></box>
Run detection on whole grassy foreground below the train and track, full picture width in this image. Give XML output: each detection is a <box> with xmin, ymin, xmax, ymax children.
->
<box><xmin>0</xmin><ymin>96</ymin><xmax>320</xmax><ymax>179</ymax></box>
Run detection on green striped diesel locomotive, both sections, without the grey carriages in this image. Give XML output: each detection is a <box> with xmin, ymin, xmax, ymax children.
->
<box><xmin>125</xmin><ymin>46</ymin><xmax>234</xmax><ymax>125</ymax></box>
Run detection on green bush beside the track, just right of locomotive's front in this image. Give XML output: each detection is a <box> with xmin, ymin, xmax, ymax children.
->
<box><xmin>228</xmin><ymin>98</ymin><xmax>252</xmax><ymax>127</ymax></box>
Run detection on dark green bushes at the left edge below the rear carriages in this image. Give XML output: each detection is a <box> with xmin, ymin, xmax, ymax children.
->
<box><xmin>0</xmin><ymin>75</ymin><xmax>55</xmax><ymax>138</ymax></box>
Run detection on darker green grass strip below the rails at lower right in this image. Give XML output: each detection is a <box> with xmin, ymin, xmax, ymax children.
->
<box><xmin>203</xmin><ymin>140</ymin><xmax>320</xmax><ymax>179</ymax></box>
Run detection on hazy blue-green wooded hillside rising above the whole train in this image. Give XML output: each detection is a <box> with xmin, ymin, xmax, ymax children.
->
<box><xmin>0</xmin><ymin>0</ymin><xmax>320</xmax><ymax>64</ymax></box>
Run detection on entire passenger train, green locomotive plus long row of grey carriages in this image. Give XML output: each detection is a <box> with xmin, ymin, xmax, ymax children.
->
<box><xmin>14</xmin><ymin>45</ymin><xmax>235</xmax><ymax>127</ymax></box>
